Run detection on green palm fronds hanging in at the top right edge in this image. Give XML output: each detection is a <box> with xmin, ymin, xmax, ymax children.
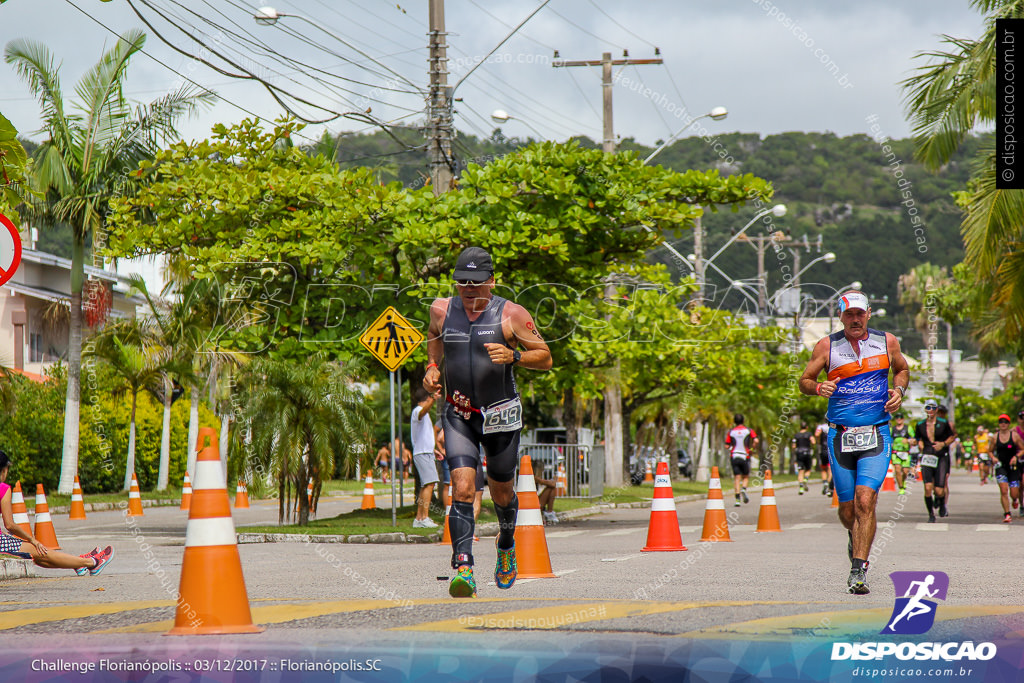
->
<box><xmin>902</xmin><ymin>0</ymin><xmax>1024</xmax><ymax>355</ymax></box>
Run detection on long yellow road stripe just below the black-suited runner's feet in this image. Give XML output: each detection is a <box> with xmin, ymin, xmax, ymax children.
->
<box><xmin>391</xmin><ymin>600</ymin><xmax>793</xmax><ymax>632</ymax></box>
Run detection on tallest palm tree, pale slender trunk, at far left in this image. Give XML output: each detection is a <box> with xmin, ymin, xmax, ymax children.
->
<box><xmin>4</xmin><ymin>30</ymin><xmax>213</xmax><ymax>494</ymax></box>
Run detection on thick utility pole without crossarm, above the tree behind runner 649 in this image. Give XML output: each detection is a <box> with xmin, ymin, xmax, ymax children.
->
<box><xmin>427</xmin><ymin>0</ymin><xmax>453</xmax><ymax>197</ymax></box>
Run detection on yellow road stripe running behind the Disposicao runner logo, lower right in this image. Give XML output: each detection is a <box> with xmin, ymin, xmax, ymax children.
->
<box><xmin>678</xmin><ymin>605</ymin><xmax>1024</xmax><ymax>640</ymax></box>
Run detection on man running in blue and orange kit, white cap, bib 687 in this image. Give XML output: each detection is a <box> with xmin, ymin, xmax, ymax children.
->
<box><xmin>800</xmin><ymin>291</ymin><xmax>910</xmax><ymax>595</ymax></box>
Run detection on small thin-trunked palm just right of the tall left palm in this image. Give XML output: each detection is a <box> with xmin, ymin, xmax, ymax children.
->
<box><xmin>86</xmin><ymin>318</ymin><xmax>170</xmax><ymax>490</ymax></box>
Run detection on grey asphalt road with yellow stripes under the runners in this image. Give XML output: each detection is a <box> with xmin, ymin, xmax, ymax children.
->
<box><xmin>0</xmin><ymin>472</ymin><xmax>1024</xmax><ymax>679</ymax></box>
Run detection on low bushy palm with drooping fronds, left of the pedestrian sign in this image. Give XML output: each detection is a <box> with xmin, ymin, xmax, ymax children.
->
<box><xmin>237</xmin><ymin>356</ymin><xmax>372</xmax><ymax>525</ymax></box>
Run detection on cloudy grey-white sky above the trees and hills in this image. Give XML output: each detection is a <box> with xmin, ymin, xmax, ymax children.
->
<box><xmin>0</xmin><ymin>0</ymin><xmax>982</xmax><ymax>144</ymax></box>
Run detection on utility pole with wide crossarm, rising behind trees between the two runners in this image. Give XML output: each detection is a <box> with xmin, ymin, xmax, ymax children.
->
<box><xmin>551</xmin><ymin>52</ymin><xmax>663</xmax><ymax>486</ymax></box>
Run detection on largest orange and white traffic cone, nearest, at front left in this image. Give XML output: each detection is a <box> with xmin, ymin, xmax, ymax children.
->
<box><xmin>167</xmin><ymin>446</ymin><xmax>263</xmax><ymax>636</ymax></box>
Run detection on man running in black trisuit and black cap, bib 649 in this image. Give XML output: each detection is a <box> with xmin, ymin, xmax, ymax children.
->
<box><xmin>423</xmin><ymin>247</ymin><xmax>551</xmax><ymax>598</ymax></box>
